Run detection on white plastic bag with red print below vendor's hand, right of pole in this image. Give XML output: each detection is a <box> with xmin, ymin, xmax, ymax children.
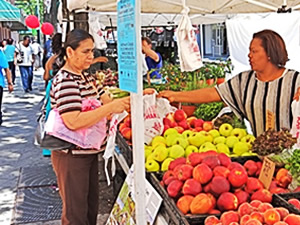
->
<box><xmin>143</xmin><ymin>93</ymin><xmax>176</xmax><ymax>144</ymax></box>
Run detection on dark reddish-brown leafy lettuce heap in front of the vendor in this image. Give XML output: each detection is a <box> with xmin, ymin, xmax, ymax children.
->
<box><xmin>252</xmin><ymin>128</ymin><xmax>297</xmax><ymax>156</ymax></box>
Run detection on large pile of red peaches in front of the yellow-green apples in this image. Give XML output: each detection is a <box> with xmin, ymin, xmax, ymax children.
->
<box><xmin>161</xmin><ymin>151</ymin><xmax>291</xmax><ymax>214</ymax></box>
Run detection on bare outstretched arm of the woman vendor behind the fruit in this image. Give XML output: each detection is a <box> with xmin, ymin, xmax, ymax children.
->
<box><xmin>158</xmin><ymin>87</ymin><xmax>222</xmax><ymax>103</ymax></box>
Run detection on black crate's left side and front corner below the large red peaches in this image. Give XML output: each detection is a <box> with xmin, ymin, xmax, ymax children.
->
<box><xmin>147</xmin><ymin>173</ymin><xmax>218</xmax><ymax>225</ymax></box>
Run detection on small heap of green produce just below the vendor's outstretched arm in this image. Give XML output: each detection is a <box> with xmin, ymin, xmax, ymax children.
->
<box><xmin>194</xmin><ymin>102</ymin><xmax>224</xmax><ymax>121</ymax></box>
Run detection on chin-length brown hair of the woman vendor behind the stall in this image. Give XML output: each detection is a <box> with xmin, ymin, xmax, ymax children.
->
<box><xmin>253</xmin><ymin>30</ymin><xmax>289</xmax><ymax>68</ymax></box>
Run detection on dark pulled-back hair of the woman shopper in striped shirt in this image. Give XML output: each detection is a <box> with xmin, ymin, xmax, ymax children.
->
<box><xmin>52</xmin><ymin>29</ymin><xmax>94</xmax><ymax>75</ymax></box>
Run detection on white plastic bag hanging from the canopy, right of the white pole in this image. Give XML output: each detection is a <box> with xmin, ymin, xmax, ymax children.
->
<box><xmin>176</xmin><ymin>7</ymin><xmax>203</xmax><ymax>72</ymax></box>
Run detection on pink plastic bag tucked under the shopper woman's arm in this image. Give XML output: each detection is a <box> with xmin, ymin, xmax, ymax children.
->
<box><xmin>45</xmin><ymin>99</ymin><xmax>107</xmax><ymax>149</ymax></box>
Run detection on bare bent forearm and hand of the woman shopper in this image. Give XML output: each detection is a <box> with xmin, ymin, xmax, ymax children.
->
<box><xmin>61</xmin><ymin>97</ymin><xmax>130</xmax><ymax>130</ymax></box>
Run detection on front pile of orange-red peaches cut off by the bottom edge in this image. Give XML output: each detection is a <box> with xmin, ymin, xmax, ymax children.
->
<box><xmin>204</xmin><ymin>200</ymin><xmax>300</xmax><ymax>225</ymax></box>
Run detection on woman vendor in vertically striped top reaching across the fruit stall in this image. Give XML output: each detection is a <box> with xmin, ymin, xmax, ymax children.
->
<box><xmin>159</xmin><ymin>30</ymin><xmax>300</xmax><ymax>136</ymax></box>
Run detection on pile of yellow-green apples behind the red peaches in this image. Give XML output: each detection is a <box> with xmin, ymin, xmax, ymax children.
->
<box><xmin>145</xmin><ymin>122</ymin><xmax>255</xmax><ymax>172</ymax></box>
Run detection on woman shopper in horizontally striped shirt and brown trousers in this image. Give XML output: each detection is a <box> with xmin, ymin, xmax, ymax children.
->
<box><xmin>50</xmin><ymin>29</ymin><xmax>130</xmax><ymax>225</ymax></box>
